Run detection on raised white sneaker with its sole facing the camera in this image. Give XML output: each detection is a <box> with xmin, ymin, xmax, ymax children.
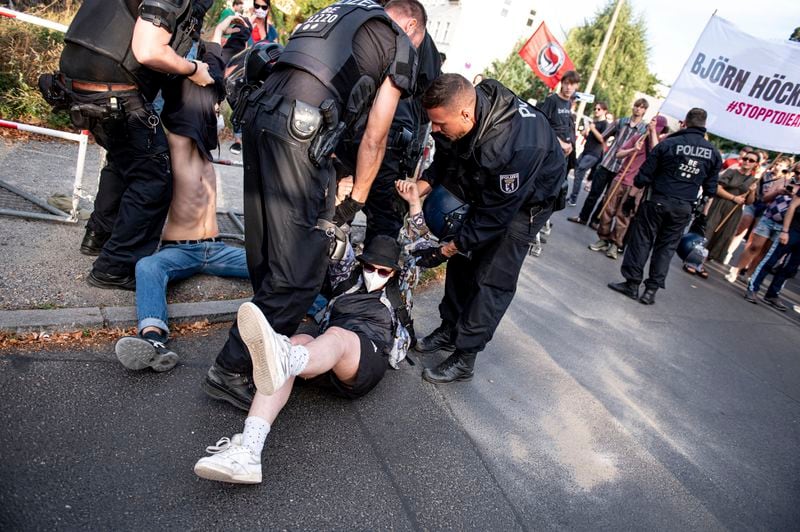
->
<box><xmin>237</xmin><ymin>303</ymin><xmax>292</xmax><ymax>395</ymax></box>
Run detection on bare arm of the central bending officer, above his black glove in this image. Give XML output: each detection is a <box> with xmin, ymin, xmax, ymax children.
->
<box><xmin>351</xmin><ymin>77</ymin><xmax>400</xmax><ymax>203</ymax></box>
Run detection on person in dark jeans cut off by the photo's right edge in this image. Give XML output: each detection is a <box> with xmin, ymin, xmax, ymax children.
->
<box><xmin>744</xmin><ymin>185</ymin><xmax>800</xmax><ymax>312</ymax></box>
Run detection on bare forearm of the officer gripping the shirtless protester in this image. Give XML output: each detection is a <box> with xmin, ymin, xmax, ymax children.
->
<box><xmin>131</xmin><ymin>18</ymin><xmax>214</xmax><ymax>86</ymax></box>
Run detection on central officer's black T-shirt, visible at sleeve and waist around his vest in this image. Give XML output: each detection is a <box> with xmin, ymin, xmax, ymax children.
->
<box><xmin>264</xmin><ymin>20</ymin><xmax>396</xmax><ymax>109</ymax></box>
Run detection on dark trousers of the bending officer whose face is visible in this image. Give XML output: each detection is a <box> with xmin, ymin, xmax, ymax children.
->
<box><xmin>439</xmin><ymin>205</ymin><xmax>552</xmax><ymax>353</ymax></box>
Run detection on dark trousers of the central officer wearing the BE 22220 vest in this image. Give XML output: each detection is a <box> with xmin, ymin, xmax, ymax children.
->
<box><xmin>212</xmin><ymin>95</ymin><xmax>336</xmax><ymax>373</ymax></box>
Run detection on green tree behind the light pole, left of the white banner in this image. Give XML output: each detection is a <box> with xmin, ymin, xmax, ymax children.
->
<box><xmin>565</xmin><ymin>0</ymin><xmax>659</xmax><ymax>116</ymax></box>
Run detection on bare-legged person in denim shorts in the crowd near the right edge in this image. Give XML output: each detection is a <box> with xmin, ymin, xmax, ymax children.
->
<box><xmin>725</xmin><ymin>157</ymin><xmax>792</xmax><ymax>282</ymax></box>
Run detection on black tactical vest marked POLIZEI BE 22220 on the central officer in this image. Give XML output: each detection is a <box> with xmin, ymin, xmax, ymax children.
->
<box><xmin>278</xmin><ymin>0</ymin><xmax>415</xmax><ymax>127</ymax></box>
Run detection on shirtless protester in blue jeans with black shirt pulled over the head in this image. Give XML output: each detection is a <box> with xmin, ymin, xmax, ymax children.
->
<box><xmin>114</xmin><ymin>17</ymin><xmax>248</xmax><ymax>371</ymax></box>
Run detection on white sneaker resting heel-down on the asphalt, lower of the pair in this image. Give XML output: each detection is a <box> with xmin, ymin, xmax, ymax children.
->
<box><xmin>194</xmin><ymin>434</ymin><xmax>261</xmax><ymax>484</ymax></box>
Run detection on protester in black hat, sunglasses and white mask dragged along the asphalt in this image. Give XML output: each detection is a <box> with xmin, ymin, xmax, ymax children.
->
<box><xmin>194</xmin><ymin>181</ymin><xmax>424</xmax><ymax>484</ymax></box>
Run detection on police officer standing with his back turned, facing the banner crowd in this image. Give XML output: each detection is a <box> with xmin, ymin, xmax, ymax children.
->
<box><xmin>608</xmin><ymin>107</ymin><xmax>722</xmax><ymax>305</ymax></box>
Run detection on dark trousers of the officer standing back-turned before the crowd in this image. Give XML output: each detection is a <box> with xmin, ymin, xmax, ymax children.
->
<box><xmin>620</xmin><ymin>200</ymin><xmax>692</xmax><ymax>288</ymax></box>
